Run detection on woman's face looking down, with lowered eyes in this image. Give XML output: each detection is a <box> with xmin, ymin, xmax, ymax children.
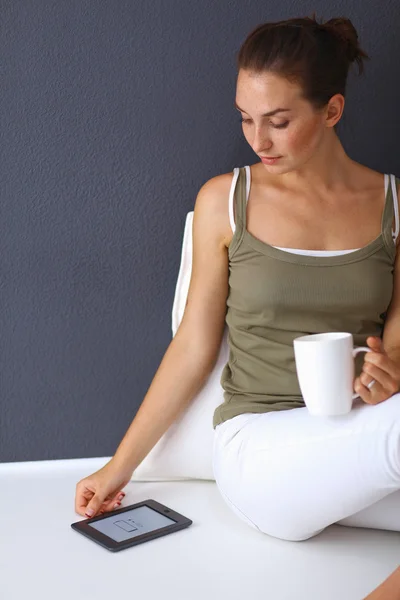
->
<box><xmin>236</xmin><ymin>69</ymin><xmax>328</xmax><ymax>173</ymax></box>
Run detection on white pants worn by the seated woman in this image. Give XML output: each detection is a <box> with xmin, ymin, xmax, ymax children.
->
<box><xmin>213</xmin><ymin>393</ymin><xmax>400</xmax><ymax>541</ymax></box>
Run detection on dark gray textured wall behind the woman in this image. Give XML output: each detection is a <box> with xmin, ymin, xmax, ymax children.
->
<box><xmin>0</xmin><ymin>0</ymin><xmax>400</xmax><ymax>461</ymax></box>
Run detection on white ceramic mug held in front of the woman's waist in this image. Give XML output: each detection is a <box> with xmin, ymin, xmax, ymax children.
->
<box><xmin>293</xmin><ymin>332</ymin><xmax>375</xmax><ymax>416</ymax></box>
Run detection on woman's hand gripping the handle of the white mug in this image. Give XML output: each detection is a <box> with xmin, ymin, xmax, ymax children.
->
<box><xmin>354</xmin><ymin>337</ymin><xmax>400</xmax><ymax>404</ymax></box>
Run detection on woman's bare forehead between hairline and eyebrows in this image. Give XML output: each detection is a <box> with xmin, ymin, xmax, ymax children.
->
<box><xmin>236</xmin><ymin>69</ymin><xmax>301</xmax><ymax>109</ymax></box>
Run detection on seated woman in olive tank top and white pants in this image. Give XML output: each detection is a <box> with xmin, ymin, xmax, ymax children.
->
<box><xmin>75</xmin><ymin>16</ymin><xmax>400</xmax><ymax>556</ymax></box>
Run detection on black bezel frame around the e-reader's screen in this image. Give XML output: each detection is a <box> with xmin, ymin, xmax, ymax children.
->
<box><xmin>71</xmin><ymin>499</ymin><xmax>193</xmax><ymax>552</ymax></box>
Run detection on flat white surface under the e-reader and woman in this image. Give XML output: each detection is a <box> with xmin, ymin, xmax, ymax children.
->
<box><xmin>0</xmin><ymin>459</ymin><xmax>400</xmax><ymax>600</ymax></box>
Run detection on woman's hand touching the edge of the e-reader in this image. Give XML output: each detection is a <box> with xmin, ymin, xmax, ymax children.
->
<box><xmin>75</xmin><ymin>460</ymin><xmax>132</xmax><ymax>517</ymax></box>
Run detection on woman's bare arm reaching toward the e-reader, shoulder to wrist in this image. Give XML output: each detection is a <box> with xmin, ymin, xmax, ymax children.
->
<box><xmin>112</xmin><ymin>174</ymin><xmax>231</xmax><ymax>473</ymax></box>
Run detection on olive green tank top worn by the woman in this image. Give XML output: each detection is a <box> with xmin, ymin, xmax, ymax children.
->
<box><xmin>213</xmin><ymin>167</ymin><xmax>399</xmax><ymax>428</ymax></box>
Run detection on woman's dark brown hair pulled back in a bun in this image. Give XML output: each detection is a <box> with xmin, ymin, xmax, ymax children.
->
<box><xmin>237</xmin><ymin>13</ymin><xmax>369</xmax><ymax>109</ymax></box>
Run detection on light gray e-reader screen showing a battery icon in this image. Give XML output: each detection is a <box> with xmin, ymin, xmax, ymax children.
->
<box><xmin>88</xmin><ymin>506</ymin><xmax>176</xmax><ymax>542</ymax></box>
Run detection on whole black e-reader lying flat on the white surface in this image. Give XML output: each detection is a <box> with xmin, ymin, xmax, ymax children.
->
<box><xmin>71</xmin><ymin>500</ymin><xmax>193</xmax><ymax>552</ymax></box>
